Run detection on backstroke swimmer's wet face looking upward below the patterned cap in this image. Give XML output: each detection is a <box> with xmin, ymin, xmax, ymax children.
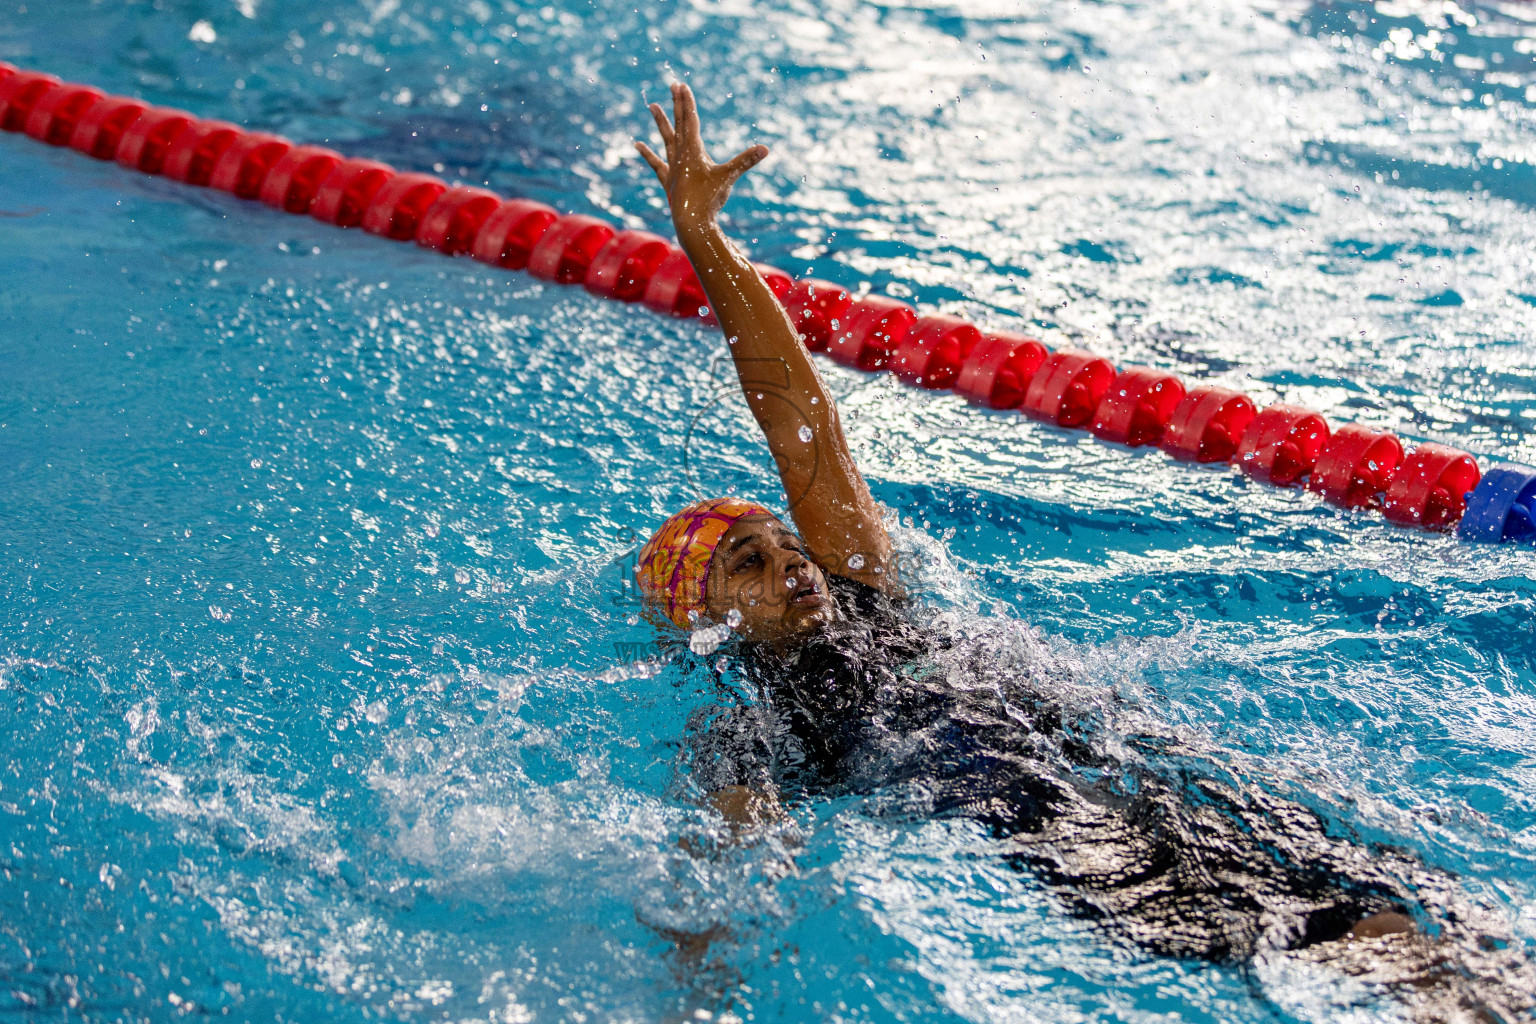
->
<box><xmin>705</xmin><ymin>516</ymin><xmax>833</xmax><ymax>640</ymax></box>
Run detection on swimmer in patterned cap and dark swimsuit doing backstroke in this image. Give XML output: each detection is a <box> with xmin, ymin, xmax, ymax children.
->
<box><xmin>636</xmin><ymin>84</ymin><xmax>1530</xmax><ymax>1019</ymax></box>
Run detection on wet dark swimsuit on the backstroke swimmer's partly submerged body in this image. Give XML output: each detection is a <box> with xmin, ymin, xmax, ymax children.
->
<box><xmin>687</xmin><ymin>577</ymin><xmax>1410</xmax><ymax>961</ymax></box>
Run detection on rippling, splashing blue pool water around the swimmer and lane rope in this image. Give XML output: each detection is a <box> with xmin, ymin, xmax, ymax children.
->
<box><xmin>0</xmin><ymin>0</ymin><xmax>1536</xmax><ymax>1024</ymax></box>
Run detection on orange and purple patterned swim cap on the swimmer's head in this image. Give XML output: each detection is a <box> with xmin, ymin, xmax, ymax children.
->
<box><xmin>637</xmin><ymin>497</ymin><xmax>773</xmax><ymax>629</ymax></box>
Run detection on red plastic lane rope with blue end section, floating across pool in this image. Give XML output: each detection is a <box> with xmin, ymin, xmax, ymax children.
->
<box><xmin>0</xmin><ymin>61</ymin><xmax>1536</xmax><ymax>542</ymax></box>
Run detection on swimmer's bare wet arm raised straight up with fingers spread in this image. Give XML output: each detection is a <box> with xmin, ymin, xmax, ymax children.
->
<box><xmin>634</xmin><ymin>83</ymin><xmax>897</xmax><ymax>591</ymax></box>
